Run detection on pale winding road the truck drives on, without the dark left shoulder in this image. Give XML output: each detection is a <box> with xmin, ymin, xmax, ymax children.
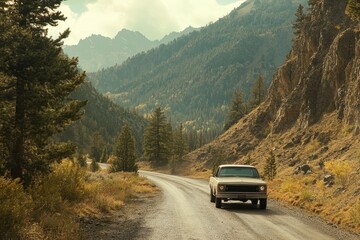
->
<box><xmin>137</xmin><ymin>171</ymin><xmax>358</xmax><ymax>240</ymax></box>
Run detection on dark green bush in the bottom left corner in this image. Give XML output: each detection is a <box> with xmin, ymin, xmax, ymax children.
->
<box><xmin>0</xmin><ymin>178</ymin><xmax>31</xmax><ymax>239</ymax></box>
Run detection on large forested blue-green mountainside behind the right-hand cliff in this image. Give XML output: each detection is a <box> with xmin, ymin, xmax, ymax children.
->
<box><xmin>89</xmin><ymin>0</ymin><xmax>306</xmax><ymax>129</ymax></box>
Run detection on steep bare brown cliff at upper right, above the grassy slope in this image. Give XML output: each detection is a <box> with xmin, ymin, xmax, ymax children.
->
<box><xmin>264</xmin><ymin>0</ymin><xmax>360</xmax><ymax>132</ymax></box>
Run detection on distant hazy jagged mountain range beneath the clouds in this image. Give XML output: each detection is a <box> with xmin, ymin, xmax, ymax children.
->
<box><xmin>63</xmin><ymin>27</ymin><xmax>196</xmax><ymax>72</ymax></box>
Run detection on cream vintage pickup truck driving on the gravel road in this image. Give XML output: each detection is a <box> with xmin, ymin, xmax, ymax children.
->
<box><xmin>209</xmin><ymin>165</ymin><xmax>267</xmax><ymax>209</ymax></box>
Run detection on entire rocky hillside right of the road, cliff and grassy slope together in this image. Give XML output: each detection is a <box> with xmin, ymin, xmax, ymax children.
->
<box><xmin>187</xmin><ymin>0</ymin><xmax>360</xmax><ymax>232</ymax></box>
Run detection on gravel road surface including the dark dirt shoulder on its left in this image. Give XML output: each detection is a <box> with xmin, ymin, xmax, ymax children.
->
<box><xmin>80</xmin><ymin>172</ymin><xmax>360</xmax><ymax>240</ymax></box>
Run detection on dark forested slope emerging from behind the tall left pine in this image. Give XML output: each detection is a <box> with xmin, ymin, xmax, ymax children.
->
<box><xmin>59</xmin><ymin>83</ymin><xmax>147</xmax><ymax>153</ymax></box>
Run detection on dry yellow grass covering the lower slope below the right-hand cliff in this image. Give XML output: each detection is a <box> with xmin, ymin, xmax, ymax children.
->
<box><xmin>187</xmin><ymin>114</ymin><xmax>360</xmax><ymax>233</ymax></box>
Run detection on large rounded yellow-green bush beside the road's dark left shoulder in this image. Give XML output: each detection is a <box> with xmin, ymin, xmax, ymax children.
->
<box><xmin>30</xmin><ymin>160</ymin><xmax>86</xmax><ymax>239</ymax></box>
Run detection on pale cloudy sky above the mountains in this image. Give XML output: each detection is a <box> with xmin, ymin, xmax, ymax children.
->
<box><xmin>49</xmin><ymin>0</ymin><xmax>245</xmax><ymax>45</ymax></box>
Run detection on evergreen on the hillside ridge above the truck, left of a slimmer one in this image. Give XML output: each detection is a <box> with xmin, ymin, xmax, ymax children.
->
<box><xmin>224</xmin><ymin>90</ymin><xmax>248</xmax><ymax>130</ymax></box>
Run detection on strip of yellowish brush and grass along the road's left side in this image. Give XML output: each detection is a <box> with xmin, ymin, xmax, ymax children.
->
<box><xmin>0</xmin><ymin>160</ymin><xmax>157</xmax><ymax>240</ymax></box>
